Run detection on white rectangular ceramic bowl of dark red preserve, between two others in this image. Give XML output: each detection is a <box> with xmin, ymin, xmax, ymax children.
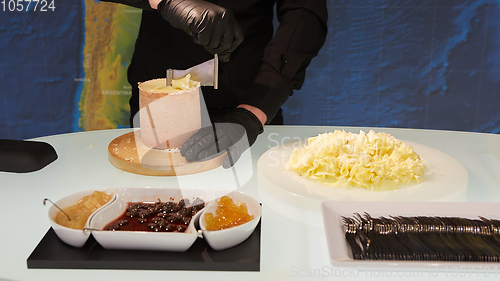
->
<box><xmin>90</xmin><ymin>187</ymin><xmax>213</xmax><ymax>252</ymax></box>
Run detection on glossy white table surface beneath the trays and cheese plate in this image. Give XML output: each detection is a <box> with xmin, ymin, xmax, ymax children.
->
<box><xmin>0</xmin><ymin>126</ymin><xmax>500</xmax><ymax>281</ymax></box>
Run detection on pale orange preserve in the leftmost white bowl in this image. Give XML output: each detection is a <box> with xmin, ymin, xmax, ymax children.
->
<box><xmin>54</xmin><ymin>191</ymin><xmax>112</xmax><ymax>229</ymax></box>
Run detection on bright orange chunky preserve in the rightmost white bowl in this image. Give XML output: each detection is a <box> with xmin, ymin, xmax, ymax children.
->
<box><xmin>205</xmin><ymin>196</ymin><xmax>253</xmax><ymax>230</ymax></box>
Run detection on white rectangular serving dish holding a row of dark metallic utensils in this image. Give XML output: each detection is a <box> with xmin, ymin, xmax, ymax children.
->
<box><xmin>321</xmin><ymin>201</ymin><xmax>500</xmax><ymax>267</ymax></box>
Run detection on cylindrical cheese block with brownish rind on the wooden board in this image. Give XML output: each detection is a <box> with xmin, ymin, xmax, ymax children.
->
<box><xmin>139</xmin><ymin>75</ymin><xmax>201</xmax><ymax>149</ymax></box>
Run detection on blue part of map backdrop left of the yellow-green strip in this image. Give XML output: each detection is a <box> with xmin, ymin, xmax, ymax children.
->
<box><xmin>0</xmin><ymin>1</ymin><xmax>85</xmax><ymax>139</ymax></box>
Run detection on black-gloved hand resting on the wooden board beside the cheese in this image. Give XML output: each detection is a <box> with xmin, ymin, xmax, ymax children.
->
<box><xmin>181</xmin><ymin>108</ymin><xmax>264</xmax><ymax>169</ymax></box>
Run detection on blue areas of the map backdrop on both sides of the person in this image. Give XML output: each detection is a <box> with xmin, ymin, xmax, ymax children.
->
<box><xmin>0</xmin><ymin>0</ymin><xmax>500</xmax><ymax>139</ymax></box>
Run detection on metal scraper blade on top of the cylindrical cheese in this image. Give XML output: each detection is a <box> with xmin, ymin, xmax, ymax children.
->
<box><xmin>167</xmin><ymin>54</ymin><xmax>219</xmax><ymax>89</ymax></box>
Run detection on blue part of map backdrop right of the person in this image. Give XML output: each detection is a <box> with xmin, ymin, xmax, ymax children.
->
<box><xmin>285</xmin><ymin>0</ymin><xmax>500</xmax><ymax>133</ymax></box>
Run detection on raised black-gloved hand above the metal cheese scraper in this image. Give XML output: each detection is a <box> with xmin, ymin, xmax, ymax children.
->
<box><xmin>158</xmin><ymin>0</ymin><xmax>243</xmax><ymax>62</ymax></box>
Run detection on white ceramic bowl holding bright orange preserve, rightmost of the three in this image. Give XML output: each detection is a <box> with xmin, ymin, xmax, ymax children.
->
<box><xmin>199</xmin><ymin>191</ymin><xmax>262</xmax><ymax>250</ymax></box>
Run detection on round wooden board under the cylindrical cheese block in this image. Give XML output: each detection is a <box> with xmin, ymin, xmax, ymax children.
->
<box><xmin>108</xmin><ymin>130</ymin><xmax>227</xmax><ymax>176</ymax></box>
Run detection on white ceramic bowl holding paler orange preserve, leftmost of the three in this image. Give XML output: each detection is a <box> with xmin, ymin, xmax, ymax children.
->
<box><xmin>49</xmin><ymin>188</ymin><xmax>116</xmax><ymax>247</ymax></box>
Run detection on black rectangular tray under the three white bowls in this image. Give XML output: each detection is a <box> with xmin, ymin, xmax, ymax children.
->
<box><xmin>27</xmin><ymin>222</ymin><xmax>261</xmax><ymax>271</ymax></box>
